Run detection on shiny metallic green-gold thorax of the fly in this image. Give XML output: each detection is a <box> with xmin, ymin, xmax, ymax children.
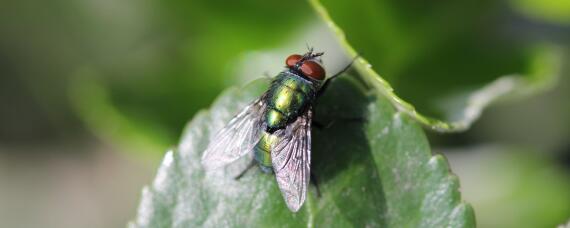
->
<box><xmin>265</xmin><ymin>71</ymin><xmax>316</xmax><ymax>132</ymax></box>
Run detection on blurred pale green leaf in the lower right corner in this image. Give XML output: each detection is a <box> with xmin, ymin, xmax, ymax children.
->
<box><xmin>444</xmin><ymin>145</ymin><xmax>570</xmax><ymax>228</ymax></box>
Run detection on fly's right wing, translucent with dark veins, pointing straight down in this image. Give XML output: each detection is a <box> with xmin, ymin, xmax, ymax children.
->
<box><xmin>271</xmin><ymin>109</ymin><xmax>312</xmax><ymax>212</ymax></box>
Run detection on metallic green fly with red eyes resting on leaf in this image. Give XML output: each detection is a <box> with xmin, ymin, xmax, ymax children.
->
<box><xmin>202</xmin><ymin>49</ymin><xmax>350</xmax><ymax>212</ymax></box>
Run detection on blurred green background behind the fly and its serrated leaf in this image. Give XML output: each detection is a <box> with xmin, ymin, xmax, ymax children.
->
<box><xmin>0</xmin><ymin>0</ymin><xmax>570</xmax><ymax>227</ymax></box>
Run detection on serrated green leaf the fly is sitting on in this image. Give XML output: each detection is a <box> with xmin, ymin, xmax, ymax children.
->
<box><xmin>130</xmin><ymin>75</ymin><xmax>475</xmax><ymax>227</ymax></box>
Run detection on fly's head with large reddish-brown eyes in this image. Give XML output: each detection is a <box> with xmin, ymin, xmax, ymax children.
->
<box><xmin>285</xmin><ymin>48</ymin><xmax>325</xmax><ymax>83</ymax></box>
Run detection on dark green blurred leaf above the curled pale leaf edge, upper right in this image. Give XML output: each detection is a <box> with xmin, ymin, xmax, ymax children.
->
<box><xmin>323</xmin><ymin>0</ymin><xmax>551</xmax><ymax>118</ymax></box>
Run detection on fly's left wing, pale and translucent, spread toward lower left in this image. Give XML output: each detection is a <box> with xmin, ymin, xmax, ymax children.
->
<box><xmin>202</xmin><ymin>96</ymin><xmax>266</xmax><ymax>169</ymax></box>
